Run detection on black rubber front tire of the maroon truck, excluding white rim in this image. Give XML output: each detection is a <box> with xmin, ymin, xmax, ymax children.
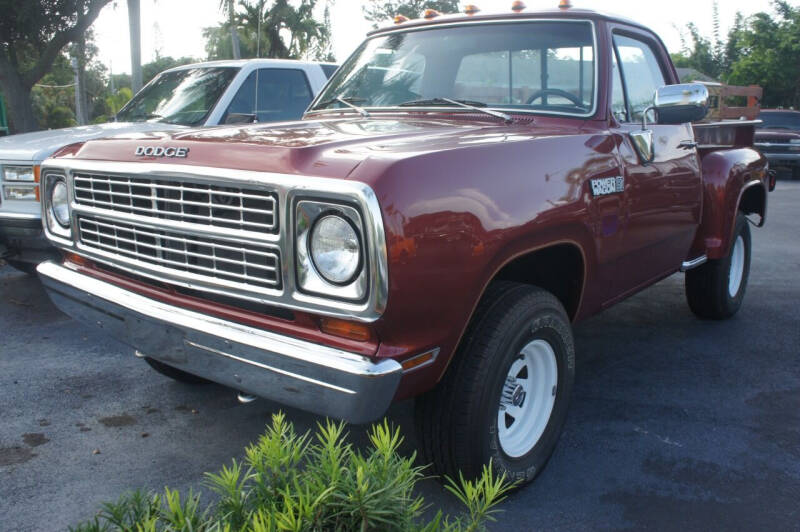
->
<box><xmin>415</xmin><ymin>282</ymin><xmax>575</xmax><ymax>485</ymax></box>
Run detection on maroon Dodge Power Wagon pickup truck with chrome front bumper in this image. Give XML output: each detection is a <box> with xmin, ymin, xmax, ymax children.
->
<box><xmin>39</xmin><ymin>4</ymin><xmax>770</xmax><ymax>482</ymax></box>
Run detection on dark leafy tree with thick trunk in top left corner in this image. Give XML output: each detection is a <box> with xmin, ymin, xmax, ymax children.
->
<box><xmin>0</xmin><ymin>0</ymin><xmax>111</xmax><ymax>132</ymax></box>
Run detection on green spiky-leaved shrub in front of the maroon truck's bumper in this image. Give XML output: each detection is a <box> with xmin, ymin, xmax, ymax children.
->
<box><xmin>70</xmin><ymin>413</ymin><xmax>512</xmax><ymax>532</ymax></box>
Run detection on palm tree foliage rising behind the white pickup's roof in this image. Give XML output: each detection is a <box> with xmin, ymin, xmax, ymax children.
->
<box><xmin>203</xmin><ymin>0</ymin><xmax>334</xmax><ymax>61</ymax></box>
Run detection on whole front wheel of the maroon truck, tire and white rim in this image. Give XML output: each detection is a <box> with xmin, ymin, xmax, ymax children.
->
<box><xmin>416</xmin><ymin>282</ymin><xmax>575</xmax><ymax>484</ymax></box>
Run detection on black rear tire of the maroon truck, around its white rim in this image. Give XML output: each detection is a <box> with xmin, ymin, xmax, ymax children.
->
<box><xmin>686</xmin><ymin>213</ymin><xmax>751</xmax><ymax>320</ymax></box>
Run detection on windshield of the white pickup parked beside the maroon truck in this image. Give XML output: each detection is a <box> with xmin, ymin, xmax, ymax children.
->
<box><xmin>117</xmin><ymin>67</ymin><xmax>239</xmax><ymax>126</ymax></box>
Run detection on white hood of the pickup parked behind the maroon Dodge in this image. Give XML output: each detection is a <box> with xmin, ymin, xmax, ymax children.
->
<box><xmin>0</xmin><ymin>122</ymin><xmax>184</xmax><ymax>163</ymax></box>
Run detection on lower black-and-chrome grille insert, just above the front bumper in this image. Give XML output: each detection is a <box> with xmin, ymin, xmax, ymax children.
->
<box><xmin>78</xmin><ymin>216</ymin><xmax>281</xmax><ymax>289</ymax></box>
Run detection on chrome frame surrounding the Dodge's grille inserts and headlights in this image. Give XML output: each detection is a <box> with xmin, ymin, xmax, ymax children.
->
<box><xmin>42</xmin><ymin>159</ymin><xmax>389</xmax><ymax>322</ymax></box>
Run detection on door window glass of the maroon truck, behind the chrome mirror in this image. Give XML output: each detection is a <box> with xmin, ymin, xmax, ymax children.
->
<box><xmin>614</xmin><ymin>35</ymin><xmax>667</xmax><ymax>122</ymax></box>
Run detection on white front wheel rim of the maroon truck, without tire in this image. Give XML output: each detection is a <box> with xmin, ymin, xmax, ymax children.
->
<box><xmin>497</xmin><ymin>340</ymin><xmax>558</xmax><ymax>458</ymax></box>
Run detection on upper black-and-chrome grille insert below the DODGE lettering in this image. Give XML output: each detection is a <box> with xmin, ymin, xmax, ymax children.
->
<box><xmin>73</xmin><ymin>173</ymin><xmax>278</xmax><ymax>233</ymax></box>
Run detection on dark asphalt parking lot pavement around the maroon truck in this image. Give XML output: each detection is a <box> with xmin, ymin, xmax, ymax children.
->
<box><xmin>0</xmin><ymin>183</ymin><xmax>800</xmax><ymax>531</ymax></box>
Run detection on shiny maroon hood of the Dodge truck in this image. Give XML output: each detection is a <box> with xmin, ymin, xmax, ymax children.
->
<box><xmin>60</xmin><ymin>114</ymin><xmax>577</xmax><ymax>178</ymax></box>
